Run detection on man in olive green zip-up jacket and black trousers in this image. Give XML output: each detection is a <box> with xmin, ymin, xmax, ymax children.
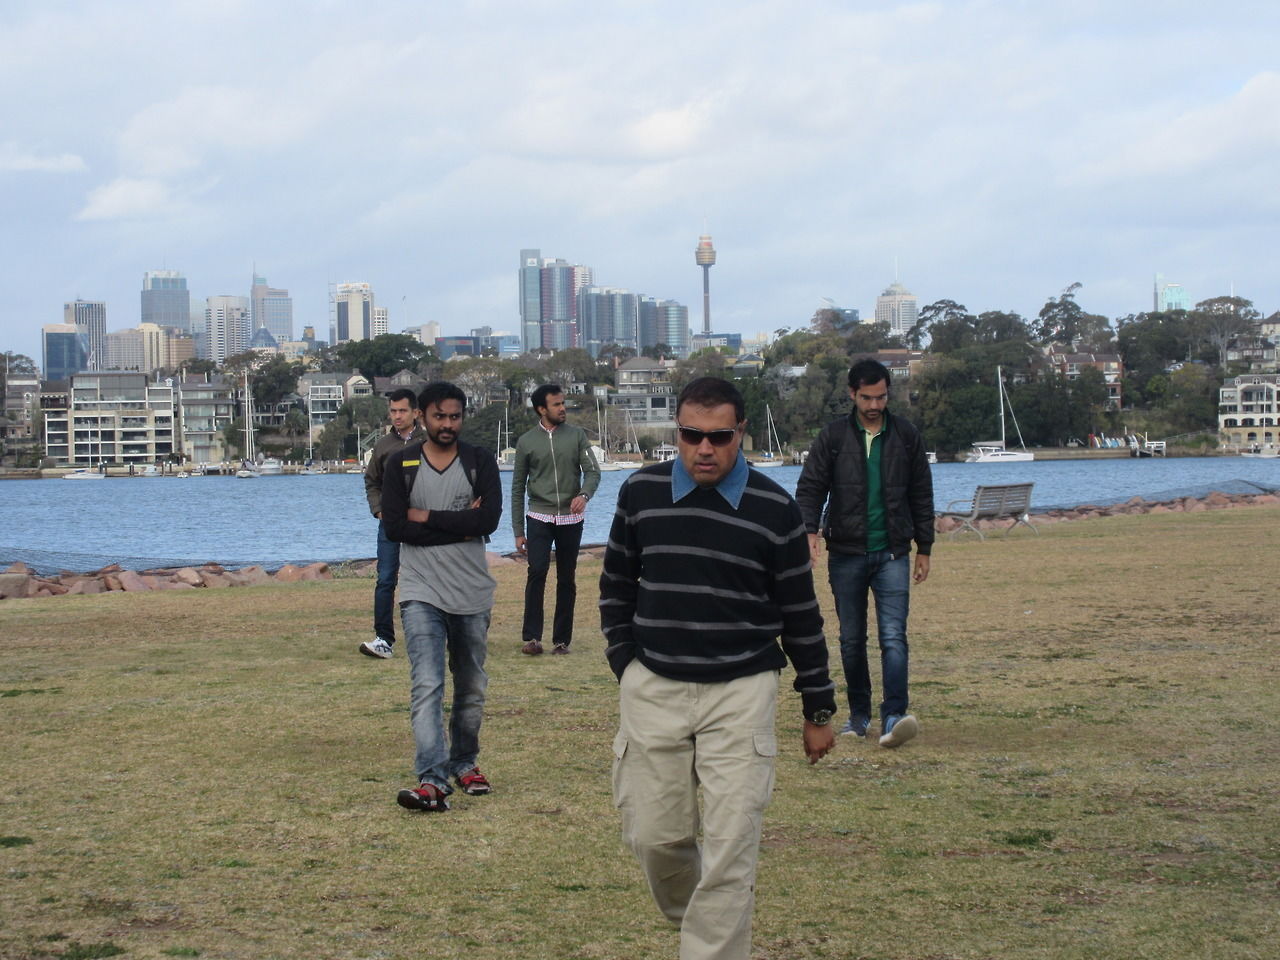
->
<box><xmin>511</xmin><ymin>383</ymin><xmax>600</xmax><ymax>657</ymax></box>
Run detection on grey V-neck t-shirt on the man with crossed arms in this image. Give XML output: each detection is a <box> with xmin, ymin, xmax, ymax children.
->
<box><xmin>399</xmin><ymin>454</ymin><xmax>498</xmax><ymax>614</ymax></box>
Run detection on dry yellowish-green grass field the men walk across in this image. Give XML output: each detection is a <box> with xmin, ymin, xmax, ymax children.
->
<box><xmin>0</xmin><ymin>507</ymin><xmax>1280</xmax><ymax>960</ymax></box>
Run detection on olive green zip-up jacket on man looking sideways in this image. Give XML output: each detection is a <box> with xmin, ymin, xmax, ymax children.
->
<box><xmin>511</xmin><ymin>422</ymin><xmax>600</xmax><ymax>536</ymax></box>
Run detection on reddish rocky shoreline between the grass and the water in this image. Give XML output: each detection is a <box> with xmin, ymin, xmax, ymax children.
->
<box><xmin>0</xmin><ymin>490</ymin><xmax>1280</xmax><ymax>599</ymax></box>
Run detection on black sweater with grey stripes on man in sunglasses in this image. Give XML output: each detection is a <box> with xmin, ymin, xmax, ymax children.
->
<box><xmin>600</xmin><ymin>462</ymin><xmax>836</xmax><ymax>717</ymax></box>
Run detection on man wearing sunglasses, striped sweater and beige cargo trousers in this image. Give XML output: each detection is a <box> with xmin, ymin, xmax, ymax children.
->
<box><xmin>600</xmin><ymin>376</ymin><xmax>836</xmax><ymax>960</ymax></box>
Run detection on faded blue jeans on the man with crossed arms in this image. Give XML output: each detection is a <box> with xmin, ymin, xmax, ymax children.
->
<box><xmin>401</xmin><ymin>600</ymin><xmax>489</xmax><ymax>794</ymax></box>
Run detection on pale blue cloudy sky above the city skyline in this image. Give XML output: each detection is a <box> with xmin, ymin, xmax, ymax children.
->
<box><xmin>0</xmin><ymin>0</ymin><xmax>1280</xmax><ymax>362</ymax></box>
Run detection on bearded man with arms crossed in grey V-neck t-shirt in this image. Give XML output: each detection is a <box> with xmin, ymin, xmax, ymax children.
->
<box><xmin>383</xmin><ymin>383</ymin><xmax>502</xmax><ymax>812</ymax></box>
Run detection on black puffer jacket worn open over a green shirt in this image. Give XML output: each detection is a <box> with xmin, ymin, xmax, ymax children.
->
<box><xmin>796</xmin><ymin>411</ymin><xmax>933</xmax><ymax>557</ymax></box>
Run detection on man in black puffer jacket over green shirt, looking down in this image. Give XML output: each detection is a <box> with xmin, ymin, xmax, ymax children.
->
<box><xmin>796</xmin><ymin>360</ymin><xmax>933</xmax><ymax>746</ymax></box>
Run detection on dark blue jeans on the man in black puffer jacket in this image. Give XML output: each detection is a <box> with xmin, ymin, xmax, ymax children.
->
<box><xmin>827</xmin><ymin>550</ymin><xmax>911</xmax><ymax>719</ymax></box>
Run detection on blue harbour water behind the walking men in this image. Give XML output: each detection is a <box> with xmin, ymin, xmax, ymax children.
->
<box><xmin>0</xmin><ymin>457</ymin><xmax>1280</xmax><ymax>572</ymax></box>
